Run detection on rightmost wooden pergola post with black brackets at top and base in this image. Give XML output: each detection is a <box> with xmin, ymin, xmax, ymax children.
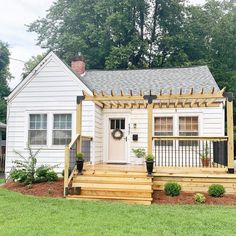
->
<box><xmin>224</xmin><ymin>93</ymin><xmax>234</xmax><ymax>173</ymax></box>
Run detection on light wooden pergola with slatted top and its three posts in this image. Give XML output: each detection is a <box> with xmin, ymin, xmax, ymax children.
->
<box><xmin>76</xmin><ymin>87</ymin><xmax>234</xmax><ymax>171</ymax></box>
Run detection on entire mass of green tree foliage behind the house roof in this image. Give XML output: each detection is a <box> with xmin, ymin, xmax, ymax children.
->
<box><xmin>29</xmin><ymin>0</ymin><xmax>236</xmax><ymax>116</ymax></box>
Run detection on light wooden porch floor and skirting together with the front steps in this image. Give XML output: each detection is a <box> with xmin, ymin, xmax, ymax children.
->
<box><xmin>67</xmin><ymin>164</ymin><xmax>236</xmax><ymax>205</ymax></box>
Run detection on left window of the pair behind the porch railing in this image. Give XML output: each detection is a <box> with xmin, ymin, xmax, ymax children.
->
<box><xmin>154</xmin><ymin>117</ymin><xmax>173</xmax><ymax>146</ymax></box>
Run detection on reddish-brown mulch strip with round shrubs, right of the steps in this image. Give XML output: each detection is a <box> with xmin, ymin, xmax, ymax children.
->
<box><xmin>153</xmin><ymin>191</ymin><xmax>236</xmax><ymax>205</ymax></box>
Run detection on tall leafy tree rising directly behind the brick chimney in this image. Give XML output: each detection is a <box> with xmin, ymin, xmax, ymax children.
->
<box><xmin>29</xmin><ymin>0</ymin><xmax>186</xmax><ymax>69</ymax></box>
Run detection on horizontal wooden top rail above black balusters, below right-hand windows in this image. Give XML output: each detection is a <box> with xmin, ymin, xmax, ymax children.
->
<box><xmin>152</xmin><ymin>136</ymin><xmax>228</xmax><ymax>141</ymax></box>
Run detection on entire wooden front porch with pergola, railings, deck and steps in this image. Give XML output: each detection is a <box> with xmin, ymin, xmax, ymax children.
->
<box><xmin>64</xmin><ymin>88</ymin><xmax>236</xmax><ymax>204</ymax></box>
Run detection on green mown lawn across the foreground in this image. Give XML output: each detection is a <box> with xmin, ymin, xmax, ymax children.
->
<box><xmin>0</xmin><ymin>189</ymin><xmax>236</xmax><ymax>236</ymax></box>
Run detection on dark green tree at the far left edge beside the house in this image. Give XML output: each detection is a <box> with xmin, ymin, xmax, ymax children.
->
<box><xmin>0</xmin><ymin>41</ymin><xmax>11</xmax><ymax>122</ymax></box>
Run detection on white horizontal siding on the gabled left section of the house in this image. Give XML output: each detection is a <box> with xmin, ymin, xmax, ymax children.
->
<box><xmin>6</xmin><ymin>56</ymin><xmax>94</xmax><ymax>173</ymax></box>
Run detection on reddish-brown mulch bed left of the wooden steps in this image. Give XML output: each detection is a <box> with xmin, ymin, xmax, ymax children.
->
<box><xmin>2</xmin><ymin>179</ymin><xmax>64</xmax><ymax>198</ymax></box>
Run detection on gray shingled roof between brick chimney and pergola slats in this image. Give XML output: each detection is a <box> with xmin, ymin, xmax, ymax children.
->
<box><xmin>80</xmin><ymin>66</ymin><xmax>219</xmax><ymax>93</ymax></box>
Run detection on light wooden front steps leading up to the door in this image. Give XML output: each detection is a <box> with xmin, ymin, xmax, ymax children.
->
<box><xmin>67</xmin><ymin>167</ymin><xmax>153</xmax><ymax>205</ymax></box>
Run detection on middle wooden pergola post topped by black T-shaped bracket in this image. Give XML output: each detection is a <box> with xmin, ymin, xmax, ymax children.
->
<box><xmin>143</xmin><ymin>92</ymin><xmax>157</xmax><ymax>155</ymax></box>
